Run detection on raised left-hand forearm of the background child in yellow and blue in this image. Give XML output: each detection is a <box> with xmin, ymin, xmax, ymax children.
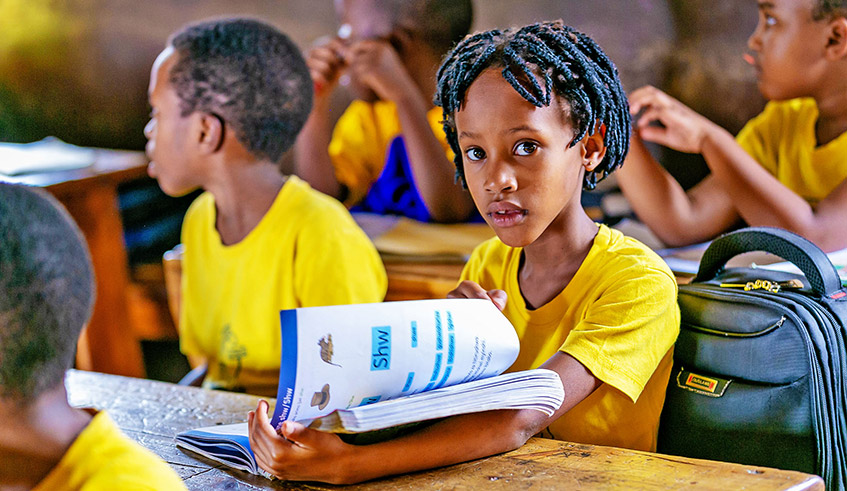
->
<box><xmin>294</xmin><ymin>39</ymin><xmax>344</xmax><ymax>199</ymax></box>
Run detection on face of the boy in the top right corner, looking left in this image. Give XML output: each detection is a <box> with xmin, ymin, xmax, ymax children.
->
<box><xmin>747</xmin><ymin>0</ymin><xmax>828</xmax><ymax>100</ymax></box>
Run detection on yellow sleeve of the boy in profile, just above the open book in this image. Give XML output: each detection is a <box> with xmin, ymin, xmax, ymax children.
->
<box><xmin>294</xmin><ymin>210</ymin><xmax>388</xmax><ymax>307</ymax></box>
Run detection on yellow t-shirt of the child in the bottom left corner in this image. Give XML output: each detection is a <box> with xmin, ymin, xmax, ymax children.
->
<box><xmin>34</xmin><ymin>411</ymin><xmax>185</xmax><ymax>491</ymax></box>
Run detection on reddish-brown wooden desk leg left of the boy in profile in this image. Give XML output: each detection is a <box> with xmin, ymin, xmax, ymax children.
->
<box><xmin>58</xmin><ymin>182</ymin><xmax>144</xmax><ymax>377</ymax></box>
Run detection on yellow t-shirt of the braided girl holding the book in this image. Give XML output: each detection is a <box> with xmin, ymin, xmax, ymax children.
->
<box><xmin>462</xmin><ymin>225</ymin><xmax>680</xmax><ymax>451</ymax></box>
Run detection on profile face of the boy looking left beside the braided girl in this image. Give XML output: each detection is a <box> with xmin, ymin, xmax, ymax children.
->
<box><xmin>144</xmin><ymin>47</ymin><xmax>200</xmax><ymax>196</ymax></box>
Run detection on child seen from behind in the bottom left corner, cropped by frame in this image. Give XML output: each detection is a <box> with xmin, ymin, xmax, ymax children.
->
<box><xmin>0</xmin><ymin>183</ymin><xmax>185</xmax><ymax>491</ymax></box>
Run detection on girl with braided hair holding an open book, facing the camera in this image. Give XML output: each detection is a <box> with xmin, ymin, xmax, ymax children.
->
<box><xmin>250</xmin><ymin>22</ymin><xmax>679</xmax><ymax>483</ymax></box>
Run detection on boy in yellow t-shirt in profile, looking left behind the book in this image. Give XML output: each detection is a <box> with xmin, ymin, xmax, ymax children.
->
<box><xmin>145</xmin><ymin>19</ymin><xmax>387</xmax><ymax>395</ymax></box>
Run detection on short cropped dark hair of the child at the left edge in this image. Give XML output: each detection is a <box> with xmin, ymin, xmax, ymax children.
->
<box><xmin>0</xmin><ymin>183</ymin><xmax>94</xmax><ymax>403</ymax></box>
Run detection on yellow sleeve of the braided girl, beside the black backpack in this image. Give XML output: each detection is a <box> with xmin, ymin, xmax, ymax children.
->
<box><xmin>560</xmin><ymin>267</ymin><xmax>680</xmax><ymax>402</ymax></box>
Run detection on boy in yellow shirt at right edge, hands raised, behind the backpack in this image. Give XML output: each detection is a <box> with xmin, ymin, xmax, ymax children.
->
<box><xmin>618</xmin><ymin>0</ymin><xmax>847</xmax><ymax>251</ymax></box>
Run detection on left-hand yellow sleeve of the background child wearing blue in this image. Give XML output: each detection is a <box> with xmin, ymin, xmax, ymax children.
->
<box><xmin>328</xmin><ymin>101</ymin><xmax>385</xmax><ymax>206</ymax></box>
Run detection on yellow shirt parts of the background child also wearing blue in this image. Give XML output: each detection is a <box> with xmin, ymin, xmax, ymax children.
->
<box><xmin>329</xmin><ymin>100</ymin><xmax>453</xmax><ymax>206</ymax></box>
